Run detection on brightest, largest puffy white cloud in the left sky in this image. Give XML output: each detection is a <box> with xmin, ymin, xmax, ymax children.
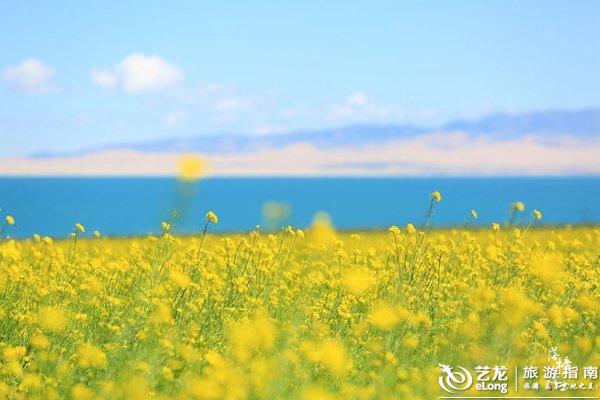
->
<box><xmin>91</xmin><ymin>53</ymin><xmax>183</xmax><ymax>93</ymax></box>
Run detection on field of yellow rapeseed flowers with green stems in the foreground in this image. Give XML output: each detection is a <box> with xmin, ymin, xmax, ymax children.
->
<box><xmin>0</xmin><ymin>202</ymin><xmax>600</xmax><ymax>400</ymax></box>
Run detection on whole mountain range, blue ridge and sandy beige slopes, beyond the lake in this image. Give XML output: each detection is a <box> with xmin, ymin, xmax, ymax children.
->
<box><xmin>8</xmin><ymin>108</ymin><xmax>600</xmax><ymax>177</ymax></box>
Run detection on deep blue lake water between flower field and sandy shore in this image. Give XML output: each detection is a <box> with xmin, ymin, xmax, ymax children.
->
<box><xmin>0</xmin><ymin>178</ymin><xmax>600</xmax><ymax>237</ymax></box>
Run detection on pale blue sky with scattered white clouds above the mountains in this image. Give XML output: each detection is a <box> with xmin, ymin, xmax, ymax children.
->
<box><xmin>0</xmin><ymin>1</ymin><xmax>600</xmax><ymax>156</ymax></box>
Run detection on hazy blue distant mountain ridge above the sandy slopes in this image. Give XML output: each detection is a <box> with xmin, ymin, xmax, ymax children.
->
<box><xmin>34</xmin><ymin>108</ymin><xmax>600</xmax><ymax>158</ymax></box>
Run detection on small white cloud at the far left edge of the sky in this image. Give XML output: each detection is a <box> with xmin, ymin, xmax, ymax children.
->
<box><xmin>2</xmin><ymin>58</ymin><xmax>58</xmax><ymax>93</ymax></box>
